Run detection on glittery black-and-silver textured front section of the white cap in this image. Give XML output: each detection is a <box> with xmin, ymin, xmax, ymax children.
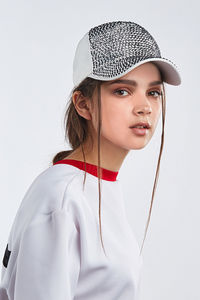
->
<box><xmin>89</xmin><ymin>21</ymin><xmax>161</xmax><ymax>77</ymax></box>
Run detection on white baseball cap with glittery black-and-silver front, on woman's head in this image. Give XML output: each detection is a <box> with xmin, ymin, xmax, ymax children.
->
<box><xmin>73</xmin><ymin>21</ymin><xmax>181</xmax><ymax>86</ymax></box>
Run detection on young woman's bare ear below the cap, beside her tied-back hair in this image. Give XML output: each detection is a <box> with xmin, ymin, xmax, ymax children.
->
<box><xmin>72</xmin><ymin>91</ymin><xmax>92</xmax><ymax>120</ymax></box>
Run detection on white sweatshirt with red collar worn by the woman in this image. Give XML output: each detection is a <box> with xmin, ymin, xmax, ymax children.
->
<box><xmin>0</xmin><ymin>159</ymin><xmax>143</xmax><ymax>300</ymax></box>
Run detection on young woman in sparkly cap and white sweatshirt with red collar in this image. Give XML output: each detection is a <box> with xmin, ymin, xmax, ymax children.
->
<box><xmin>0</xmin><ymin>21</ymin><xmax>181</xmax><ymax>300</ymax></box>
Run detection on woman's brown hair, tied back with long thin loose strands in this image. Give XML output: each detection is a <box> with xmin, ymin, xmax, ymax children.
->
<box><xmin>52</xmin><ymin>72</ymin><xmax>165</xmax><ymax>254</ymax></box>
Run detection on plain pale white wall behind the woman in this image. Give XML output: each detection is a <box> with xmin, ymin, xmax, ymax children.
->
<box><xmin>0</xmin><ymin>0</ymin><xmax>200</xmax><ymax>300</ymax></box>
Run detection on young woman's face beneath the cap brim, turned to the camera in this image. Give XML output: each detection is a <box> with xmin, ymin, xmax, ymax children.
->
<box><xmin>92</xmin><ymin>62</ymin><xmax>163</xmax><ymax>150</ymax></box>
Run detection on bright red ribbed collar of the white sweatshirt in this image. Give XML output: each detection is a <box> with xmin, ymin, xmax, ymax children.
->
<box><xmin>53</xmin><ymin>159</ymin><xmax>119</xmax><ymax>181</ymax></box>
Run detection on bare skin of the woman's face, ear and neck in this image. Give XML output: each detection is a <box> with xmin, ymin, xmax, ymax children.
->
<box><xmin>65</xmin><ymin>62</ymin><xmax>163</xmax><ymax>171</ymax></box>
